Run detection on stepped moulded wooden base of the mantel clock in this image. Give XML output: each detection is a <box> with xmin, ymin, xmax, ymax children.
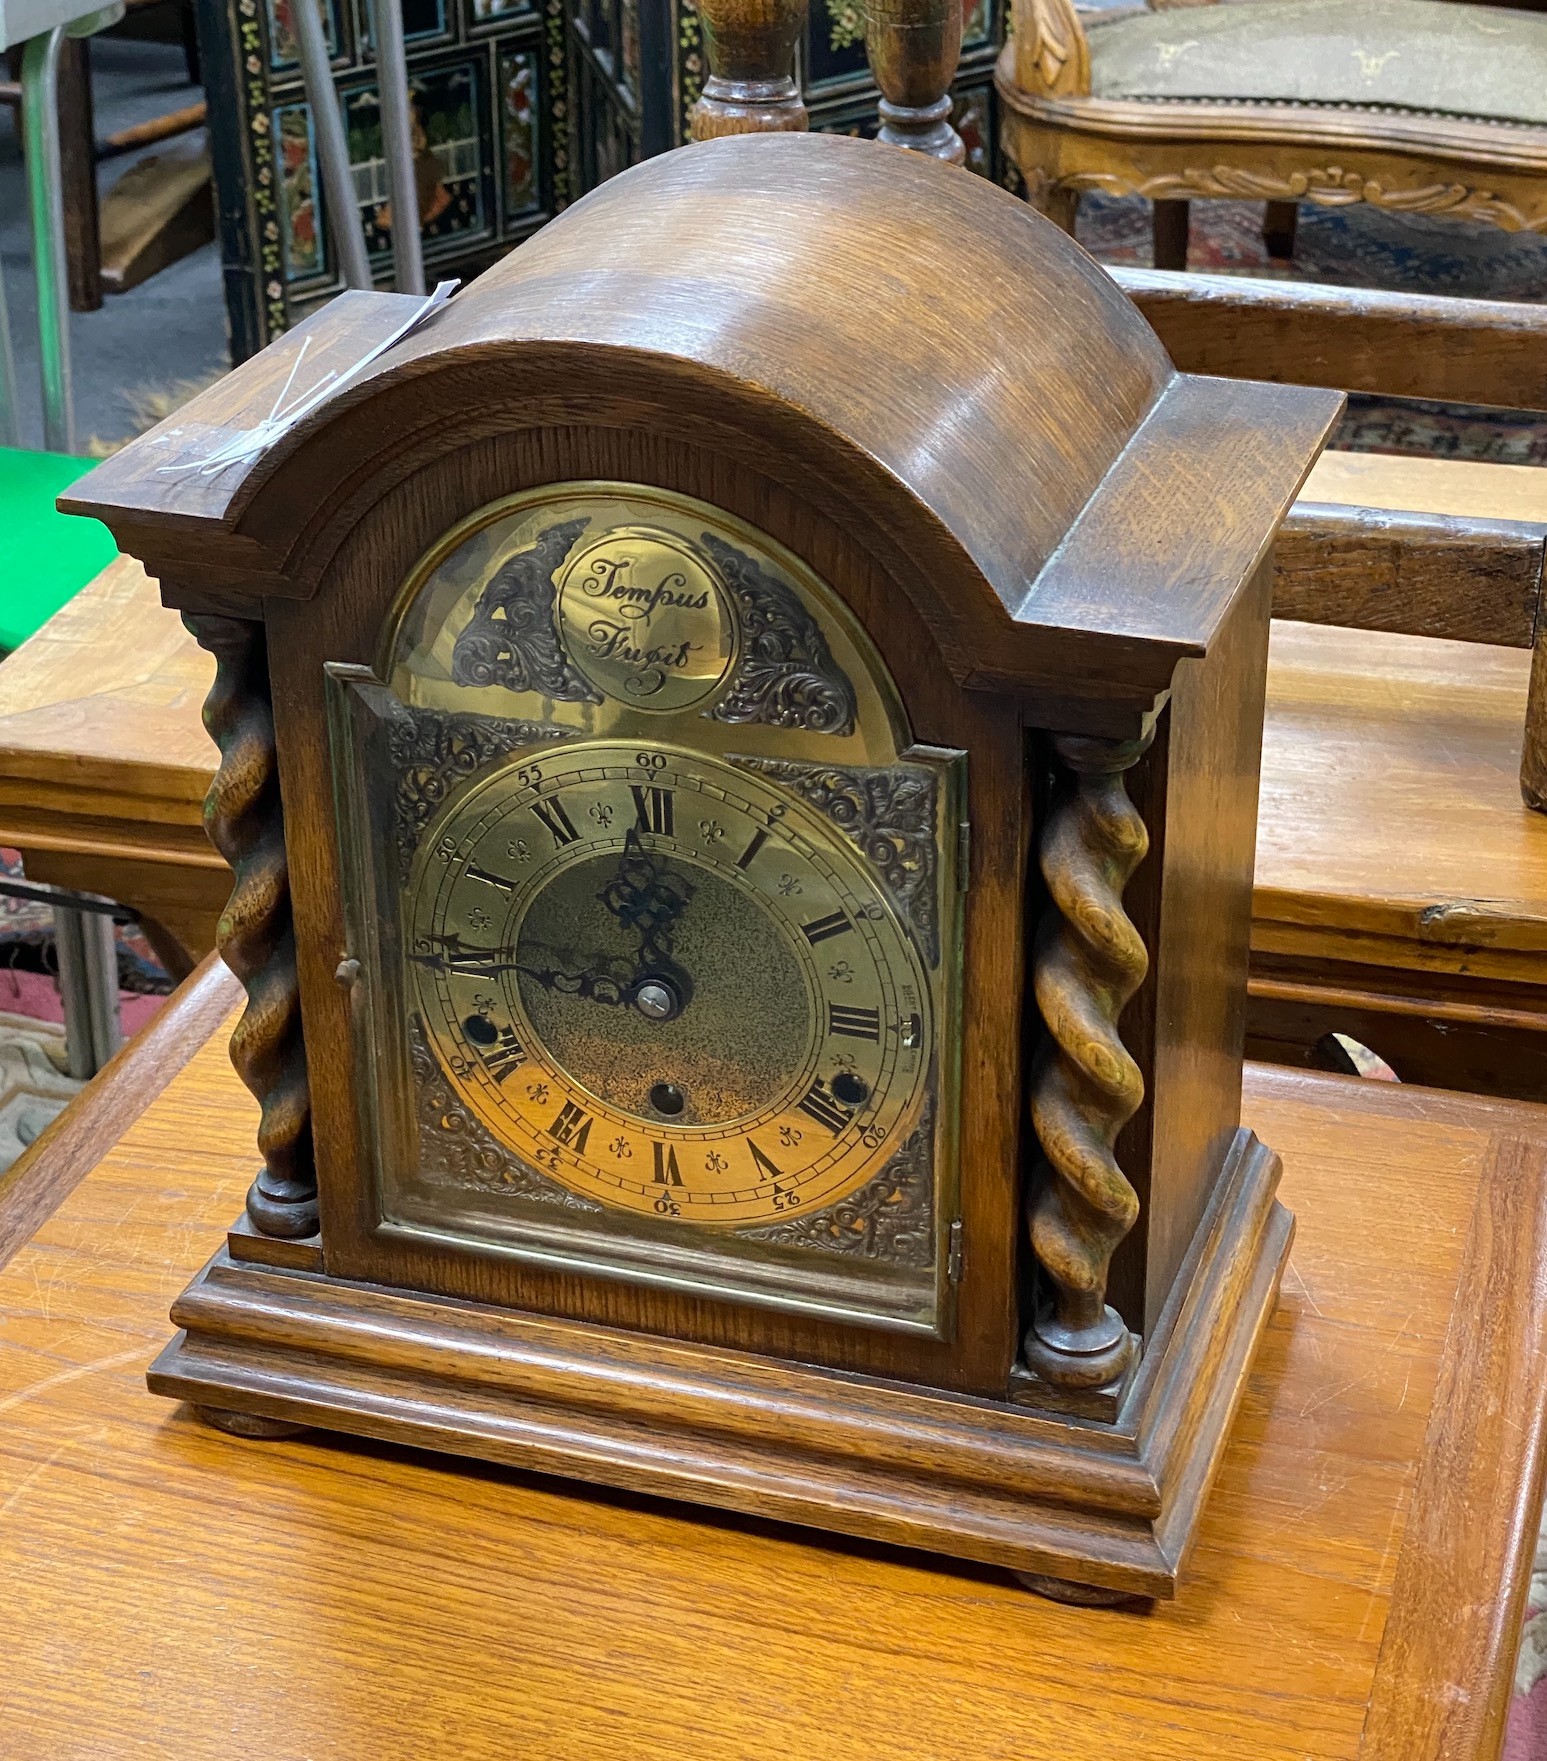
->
<box><xmin>148</xmin><ymin>1131</ymin><xmax>1293</xmax><ymax>1597</ymax></box>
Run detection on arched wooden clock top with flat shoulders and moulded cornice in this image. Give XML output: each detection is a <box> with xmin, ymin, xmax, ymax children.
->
<box><xmin>60</xmin><ymin>134</ymin><xmax>1339</xmax><ymax>701</ymax></box>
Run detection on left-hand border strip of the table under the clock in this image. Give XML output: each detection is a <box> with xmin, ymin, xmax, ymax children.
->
<box><xmin>0</xmin><ymin>954</ymin><xmax>243</xmax><ymax>1266</ymax></box>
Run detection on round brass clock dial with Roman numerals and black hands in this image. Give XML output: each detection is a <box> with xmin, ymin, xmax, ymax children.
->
<box><xmin>405</xmin><ymin>740</ymin><xmax>934</xmax><ymax>1226</ymax></box>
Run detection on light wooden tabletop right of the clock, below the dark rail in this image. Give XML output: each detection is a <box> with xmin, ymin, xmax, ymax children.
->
<box><xmin>1251</xmin><ymin>622</ymin><xmax>1547</xmax><ymax>984</ymax></box>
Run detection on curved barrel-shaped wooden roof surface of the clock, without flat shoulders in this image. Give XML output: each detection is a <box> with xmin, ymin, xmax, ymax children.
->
<box><xmin>417</xmin><ymin>134</ymin><xmax>1173</xmax><ymax>604</ymax></box>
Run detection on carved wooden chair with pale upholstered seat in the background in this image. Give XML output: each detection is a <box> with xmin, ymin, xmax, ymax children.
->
<box><xmin>997</xmin><ymin>0</ymin><xmax>1547</xmax><ymax>269</ymax></box>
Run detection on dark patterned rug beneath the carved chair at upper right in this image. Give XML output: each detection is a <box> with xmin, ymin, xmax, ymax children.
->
<box><xmin>1078</xmin><ymin>195</ymin><xmax>1547</xmax><ymax>465</ymax></box>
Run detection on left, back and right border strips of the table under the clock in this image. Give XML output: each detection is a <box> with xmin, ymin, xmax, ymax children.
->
<box><xmin>9</xmin><ymin>1007</ymin><xmax>1547</xmax><ymax>1761</ymax></box>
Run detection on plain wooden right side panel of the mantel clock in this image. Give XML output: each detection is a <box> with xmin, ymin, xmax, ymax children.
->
<box><xmin>1124</xmin><ymin>558</ymin><xmax>1272</xmax><ymax>1333</ymax></box>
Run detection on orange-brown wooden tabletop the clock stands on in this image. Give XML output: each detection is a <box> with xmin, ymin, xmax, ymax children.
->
<box><xmin>0</xmin><ymin>970</ymin><xmax>1547</xmax><ymax>1761</ymax></box>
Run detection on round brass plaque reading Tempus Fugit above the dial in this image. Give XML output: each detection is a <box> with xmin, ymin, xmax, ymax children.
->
<box><xmin>559</xmin><ymin>527</ymin><xmax>736</xmax><ymax>713</ymax></box>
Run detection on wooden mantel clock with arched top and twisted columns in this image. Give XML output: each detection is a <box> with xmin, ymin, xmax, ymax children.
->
<box><xmin>67</xmin><ymin>134</ymin><xmax>1337</xmax><ymax>1599</ymax></box>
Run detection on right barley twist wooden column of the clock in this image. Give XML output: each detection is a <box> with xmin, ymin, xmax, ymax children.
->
<box><xmin>1024</xmin><ymin>736</ymin><xmax>1149</xmax><ymax>1389</ymax></box>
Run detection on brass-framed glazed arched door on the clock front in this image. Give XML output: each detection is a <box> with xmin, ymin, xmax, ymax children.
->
<box><xmin>329</xmin><ymin>484</ymin><xmax>964</xmax><ymax>1337</ymax></box>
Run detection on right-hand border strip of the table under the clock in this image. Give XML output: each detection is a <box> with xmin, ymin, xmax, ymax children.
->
<box><xmin>1360</xmin><ymin>1122</ymin><xmax>1547</xmax><ymax>1761</ymax></box>
